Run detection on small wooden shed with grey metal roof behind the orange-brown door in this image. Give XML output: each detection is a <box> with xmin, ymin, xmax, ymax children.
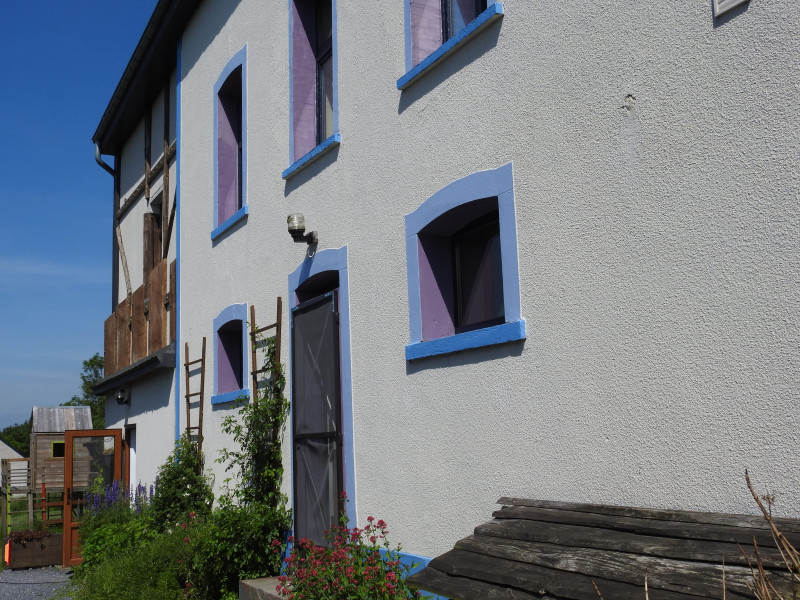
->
<box><xmin>30</xmin><ymin>406</ymin><xmax>92</xmax><ymax>493</ymax></box>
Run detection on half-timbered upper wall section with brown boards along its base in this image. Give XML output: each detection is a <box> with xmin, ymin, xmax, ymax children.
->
<box><xmin>105</xmin><ymin>74</ymin><xmax>177</xmax><ymax>377</ymax></box>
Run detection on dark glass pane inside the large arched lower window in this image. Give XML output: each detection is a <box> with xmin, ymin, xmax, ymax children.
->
<box><xmin>453</xmin><ymin>212</ymin><xmax>505</xmax><ymax>332</ymax></box>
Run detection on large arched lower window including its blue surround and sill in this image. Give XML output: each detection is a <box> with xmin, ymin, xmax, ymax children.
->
<box><xmin>406</xmin><ymin>164</ymin><xmax>525</xmax><ymax>360</ymax></box>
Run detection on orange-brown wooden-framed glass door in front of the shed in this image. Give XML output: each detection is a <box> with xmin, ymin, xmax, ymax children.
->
<box><xmin>62</xmin><ymin>429</ymin><xmax>122</xmax><ymax>567</ymax></box>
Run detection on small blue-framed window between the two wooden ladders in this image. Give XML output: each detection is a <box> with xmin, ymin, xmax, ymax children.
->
<box><xmin>211</xmin><ymin>304</ymin><xmax>250</xmax><ymax>404</ymax></box>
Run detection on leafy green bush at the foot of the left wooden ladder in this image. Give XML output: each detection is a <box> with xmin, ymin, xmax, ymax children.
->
<box><xmin>151</xmin><ymin>433</ymin><xmax>214</xmax><ymax>531</ymax></box>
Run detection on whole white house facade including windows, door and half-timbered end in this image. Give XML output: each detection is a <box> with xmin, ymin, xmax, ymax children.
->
<box><xmin>95</xmin><ymin>0</ymin><xmax>800</xmax><ymax>556</ymax></box>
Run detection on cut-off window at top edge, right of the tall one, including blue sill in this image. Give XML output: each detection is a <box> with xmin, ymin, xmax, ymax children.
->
<box><xmin>397</xmin><ymin>0</ymin><xmax>503</xmax><ymax>90</ymax></box>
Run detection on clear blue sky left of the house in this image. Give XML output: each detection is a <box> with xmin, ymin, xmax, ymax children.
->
<box><xmin>0</xmin><ymin>0</ymin><xmax>156</xmax><ymax>428</ymax></box>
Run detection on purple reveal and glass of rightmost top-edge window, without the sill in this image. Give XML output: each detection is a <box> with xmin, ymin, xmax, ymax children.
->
<box><xmin>409</xmin><ymin>0</ymin><xmax>486</xmax><ymax>66</ymax></box>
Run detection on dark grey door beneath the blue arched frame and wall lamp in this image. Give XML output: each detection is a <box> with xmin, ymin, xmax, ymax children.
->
<box><xmin>291</xmin><ymin>291</ymin><xmax>343</xmax><ymax>545</ymax></box>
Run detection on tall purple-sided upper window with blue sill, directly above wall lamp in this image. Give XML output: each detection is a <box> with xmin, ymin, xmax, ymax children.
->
<box><xmin>283</xmin><ymin>0</ymin><xmax>339</xmax><ymax>178</ymax></box>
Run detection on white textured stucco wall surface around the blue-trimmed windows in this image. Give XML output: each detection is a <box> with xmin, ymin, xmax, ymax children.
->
<box><xmin>179</xmin><ymin>0</ymin><xmax>800</xmax><ymax>555</ymax></box>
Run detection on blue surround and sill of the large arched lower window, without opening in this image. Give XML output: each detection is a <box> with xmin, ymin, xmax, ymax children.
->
<box><xmin>406</xmin><ymin>163</ymin><xmax>526</xmax><ymax>360</ymax></box>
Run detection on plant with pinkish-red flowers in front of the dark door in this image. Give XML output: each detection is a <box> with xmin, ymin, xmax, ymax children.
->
<box><xmin>276</xmin><ymin>517</ymin><xmax>421</xmax><ymax>600</ymax></box>
